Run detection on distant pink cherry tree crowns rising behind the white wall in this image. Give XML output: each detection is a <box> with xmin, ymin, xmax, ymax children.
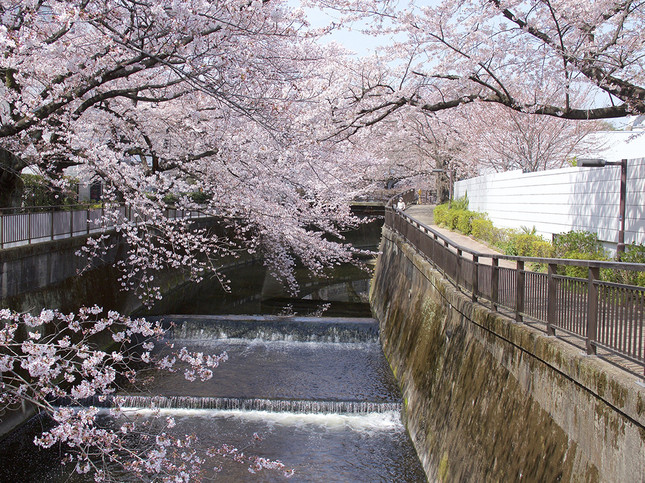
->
<box><xmin>348</xmin><ymin>97</ymin><xmax>604</xmax><ymax>202</ymax></box>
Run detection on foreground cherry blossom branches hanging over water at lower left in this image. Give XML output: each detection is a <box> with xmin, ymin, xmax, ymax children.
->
<box><xmin>0</xmin><ymin>306</ymin><xmax>288</xmax><ymax>481</ymax></box>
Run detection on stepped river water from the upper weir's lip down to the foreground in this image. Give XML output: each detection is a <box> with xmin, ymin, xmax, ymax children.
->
<box><xmin>7</xmin><ymin>315</ymin><xmax>426</xmax><ymax>483</ymax></box>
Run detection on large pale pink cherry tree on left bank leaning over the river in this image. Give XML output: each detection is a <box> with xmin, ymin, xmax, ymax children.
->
<box><xmin>0</xmin><ymin>0</ymin><xmax>380</xmax><ymax>299</ymax></box>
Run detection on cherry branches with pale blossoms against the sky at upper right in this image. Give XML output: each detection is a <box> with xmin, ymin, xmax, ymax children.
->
<box><xmin>312</xmin><ymin>0</ymin><xmax>645</xmax><ymax>134</ymax></box>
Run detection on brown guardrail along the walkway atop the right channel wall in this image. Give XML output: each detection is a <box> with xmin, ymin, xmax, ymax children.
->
<box><xmin>385</xmin><ymin>192</ymin><xmax>645</xmax><ymax>376</ymax></box>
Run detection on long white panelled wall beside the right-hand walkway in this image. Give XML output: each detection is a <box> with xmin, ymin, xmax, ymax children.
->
<box><xmin>455</xmin><ymin>158</ymin><xmax>645</xmax><ymax>250</ymax></box>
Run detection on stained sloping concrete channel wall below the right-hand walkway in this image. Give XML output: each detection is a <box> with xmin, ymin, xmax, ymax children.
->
<box><xmin>370</xmin><ymin>227</ymin><xmax>645</xmax><ymax>482</ymax></box>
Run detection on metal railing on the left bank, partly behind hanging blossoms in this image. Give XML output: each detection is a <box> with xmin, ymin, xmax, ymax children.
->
<box><xmin>0</xmin><ymin>205</ymin><xmax>207</xmax><ymax>249</ymax></box>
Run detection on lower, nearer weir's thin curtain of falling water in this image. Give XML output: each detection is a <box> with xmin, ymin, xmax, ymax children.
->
<box><xmin>52</xmin><ymin>396</ymin><xmax>402</xmax><ymax>414</ymax></box>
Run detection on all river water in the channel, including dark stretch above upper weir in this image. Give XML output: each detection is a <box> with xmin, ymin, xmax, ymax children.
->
<box><xmin>0</xmin><ymin>221</ymin><xmax>425</xmax><ymax>482</ymax></box>
